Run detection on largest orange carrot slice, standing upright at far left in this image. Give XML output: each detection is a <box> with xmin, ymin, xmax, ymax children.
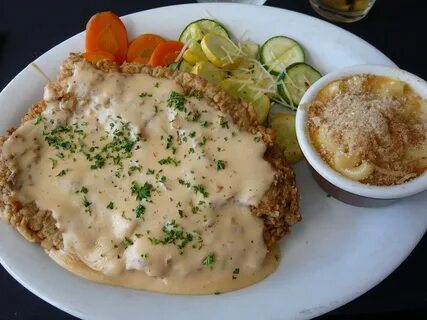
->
<box><xmin>86</xmin><ymin>11</ymin><xmax>128</xmax><ymax>64</ymax></box>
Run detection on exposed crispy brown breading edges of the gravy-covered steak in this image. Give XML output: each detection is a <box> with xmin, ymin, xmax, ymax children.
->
<box><xmin>0</xmin><ymin>54</ymin><xmax>301</xmax><ymax>250</ymax></box>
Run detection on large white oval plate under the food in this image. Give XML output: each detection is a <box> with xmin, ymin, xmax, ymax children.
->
<box><xmin>0</xmin><ymin>4</ymin><xmax>427</xmax><ymax>320</ymax></box>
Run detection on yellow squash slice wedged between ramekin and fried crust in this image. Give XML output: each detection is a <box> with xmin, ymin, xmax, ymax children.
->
<box><xmin>270</xmin><ymin>113</ymin><xmax>302</xmax><ymax>163</ymax></box>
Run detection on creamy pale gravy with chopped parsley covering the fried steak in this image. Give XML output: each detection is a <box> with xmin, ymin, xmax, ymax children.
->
<box><xmin>3</xmin><ymin>62</ymin><xmax>277</xmax><ymax>294</ymax></box>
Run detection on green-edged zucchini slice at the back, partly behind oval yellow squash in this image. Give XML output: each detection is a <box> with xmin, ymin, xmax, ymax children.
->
<box><xmin>179</xmin><ymin>19</ymin><xmax>230</xmax><ymax>43</ymax></box>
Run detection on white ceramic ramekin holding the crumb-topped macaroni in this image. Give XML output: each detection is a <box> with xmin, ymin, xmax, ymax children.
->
<box><xmin>296</xmin><ymin>65</ymin><xmax>427</xmax><ymax>207</ymax></box>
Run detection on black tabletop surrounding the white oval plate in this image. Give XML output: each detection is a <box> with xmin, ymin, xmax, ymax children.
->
<box><xmin>0</xmin><ymin>0</ymin><xmax>427</xmax><ymax>320</ymax></box>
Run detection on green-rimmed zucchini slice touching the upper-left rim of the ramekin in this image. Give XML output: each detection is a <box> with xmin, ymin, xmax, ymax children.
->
<box><xmin>277</xmin><ymin>63</ymin><xmax>322</xmax><ymax>106</ymax></box>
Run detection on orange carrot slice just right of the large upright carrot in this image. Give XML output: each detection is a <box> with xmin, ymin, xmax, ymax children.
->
<box><xmin>126</xmin><ymin>33</ymin><xmax>166</xmax><ymax>64</ymax></box>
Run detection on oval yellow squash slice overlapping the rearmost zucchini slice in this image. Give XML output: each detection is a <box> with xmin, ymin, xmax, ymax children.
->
<box><xmin>200</xmin><ymin>33</ymin><xmax>240</xmax><ymax>69</ymax></box>
